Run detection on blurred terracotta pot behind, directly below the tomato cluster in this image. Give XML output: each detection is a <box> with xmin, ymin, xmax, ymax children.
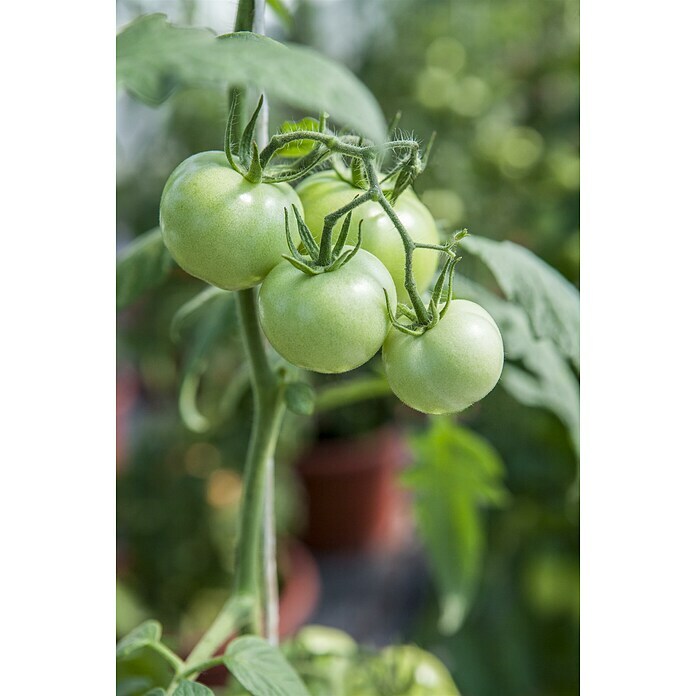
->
<box><xmin>297</xmin><ymin>426</ymin><xmax>407</xmax><ymax>550</ymax></box>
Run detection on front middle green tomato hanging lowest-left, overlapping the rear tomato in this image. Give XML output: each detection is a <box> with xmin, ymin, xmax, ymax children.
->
<box><xmin>259</xmin><ymin>249</ymin><xmax>396</xmax><ymax>373</ymax></box>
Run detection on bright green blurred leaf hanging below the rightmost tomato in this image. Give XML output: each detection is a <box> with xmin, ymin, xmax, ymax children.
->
<box><xmin>402</xmin><ymin>418</ymin><xmax>507</xmax><ymax>634</ymax></box>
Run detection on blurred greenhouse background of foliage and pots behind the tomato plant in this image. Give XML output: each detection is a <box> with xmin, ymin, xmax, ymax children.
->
<box><xmin>117</xmin><ymin>0</ymin><xmax>579</xmax><ymax>696</ymax></box>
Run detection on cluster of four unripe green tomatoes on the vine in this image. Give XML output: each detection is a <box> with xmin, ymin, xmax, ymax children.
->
<box><xmin>160</xmin><ymin>152</ymin><xmax>503</xmax><ymax>414</ymax></box>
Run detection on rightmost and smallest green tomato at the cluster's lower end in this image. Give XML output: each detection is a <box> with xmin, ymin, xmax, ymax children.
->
<box><xmin>382</xmin><ymin>300</ymin><xmax>504</xmax><ymax>414</ymax></box>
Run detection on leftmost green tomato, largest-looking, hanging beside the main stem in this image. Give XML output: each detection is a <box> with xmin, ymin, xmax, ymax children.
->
<box><xmin>160</xmin><ymin>151</ymin><xmax>302</xmax><ymax>290</ymax></box>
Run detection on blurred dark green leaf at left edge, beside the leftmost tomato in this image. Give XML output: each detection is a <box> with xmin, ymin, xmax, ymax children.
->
<box><xmin>116</xmin><ymin>227</ymin><xmax>175</xmax><ymax>309</ymax></box>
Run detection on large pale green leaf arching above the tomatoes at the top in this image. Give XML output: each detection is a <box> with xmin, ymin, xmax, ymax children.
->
<box><xmin>116</xmin><ymin>14</ymin><xmax>386</xmax><ymax>144</ymax></box>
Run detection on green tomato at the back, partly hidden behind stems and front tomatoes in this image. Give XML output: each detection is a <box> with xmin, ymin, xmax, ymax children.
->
<box><xmin>297</xmin><ymin>171</ymin><xmax>440</xmax><ymax>302</ymax></box>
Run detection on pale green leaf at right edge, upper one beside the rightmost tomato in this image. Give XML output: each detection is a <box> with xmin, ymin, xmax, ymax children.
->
<box><xmin>461</xmin><ymin>236</ymin><xmax>580</xmax><ymax>368</ymax></box>
